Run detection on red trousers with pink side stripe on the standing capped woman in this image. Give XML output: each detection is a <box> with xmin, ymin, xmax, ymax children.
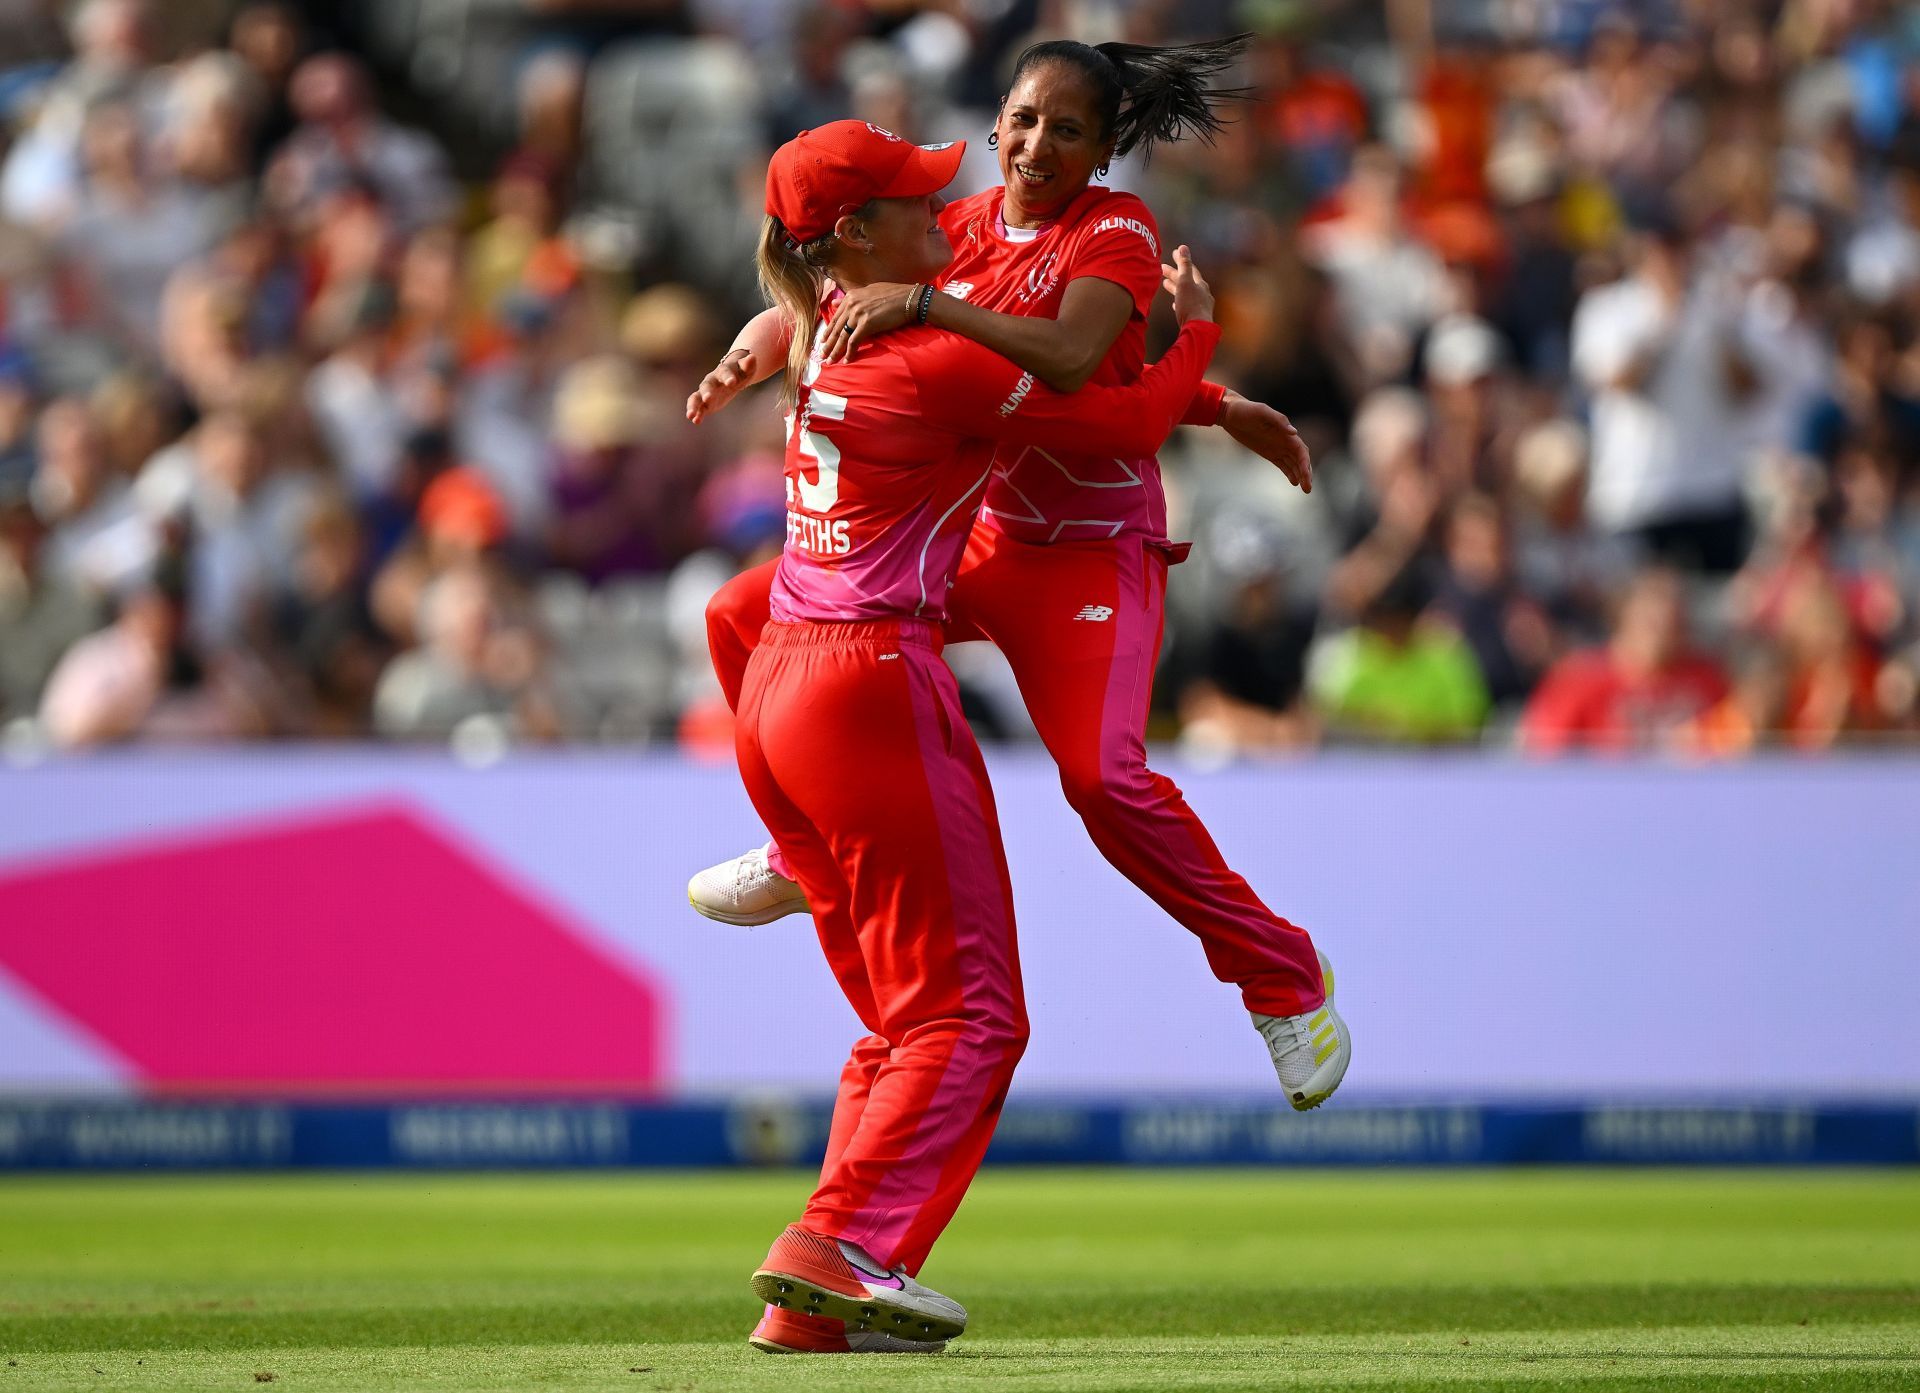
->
<box><xmin>730</xmin><ymin>620</ymin><xmax>1027</xmax><ymax>1272</ymax></box>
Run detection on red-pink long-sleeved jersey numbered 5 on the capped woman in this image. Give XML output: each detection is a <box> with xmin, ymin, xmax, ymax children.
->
<box><xmin>772</xmin><ymin>324</ymin><xmax>1219</xmax><ymax>622</ymax></box>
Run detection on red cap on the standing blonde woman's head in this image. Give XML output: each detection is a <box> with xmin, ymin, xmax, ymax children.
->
<box><xmin>766</xmin><ymin>121</ymin><xmax>966</xmax><ymax>242</ymax></box>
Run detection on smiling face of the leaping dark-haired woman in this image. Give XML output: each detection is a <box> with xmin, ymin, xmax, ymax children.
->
<box><xmin>995</xmin><ymin>63</ymin><xmax>1114</xmax><ymax>226</ymax></box>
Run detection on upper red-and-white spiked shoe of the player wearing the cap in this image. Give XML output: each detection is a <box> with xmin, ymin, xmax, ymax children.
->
<box><xmin>753</xmin><ymin>1224</ymin><xmax>966</xmax><ymax>1345</ymax></box>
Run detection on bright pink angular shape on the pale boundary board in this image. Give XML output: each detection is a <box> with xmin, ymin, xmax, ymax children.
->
<box><xmin>0</xmin><ymin>808</ymin><xmax>666</xmax><ymax>1094</ymax></box>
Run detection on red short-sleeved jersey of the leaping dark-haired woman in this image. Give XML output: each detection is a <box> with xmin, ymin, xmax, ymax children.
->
<box><xmin>939</xmin><ymin>186</ymin><xmax>1167</xmax><ymax>543</ymax></box>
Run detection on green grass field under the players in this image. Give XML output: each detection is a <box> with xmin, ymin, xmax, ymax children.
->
<box><xmin>0</xmin><ymin>1170</ymin><xmax>1920</xmax><ymax>1393</ymax></box>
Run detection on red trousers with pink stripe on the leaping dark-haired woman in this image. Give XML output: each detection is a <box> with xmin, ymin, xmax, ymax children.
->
<box><xmin>707</xmin><ymin>528</ymin><xmax>1327</xmax><ymax>1015</ymax></box>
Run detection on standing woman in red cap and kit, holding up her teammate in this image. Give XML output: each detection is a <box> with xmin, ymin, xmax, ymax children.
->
<box><xmin>735</xmin><ymin>121</ymin><xmax>1219</xmax><ymax>1351</ymax></box>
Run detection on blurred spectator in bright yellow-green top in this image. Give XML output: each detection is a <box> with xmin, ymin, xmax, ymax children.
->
<box><xmin>1308</xmin><ymin>572</ymin><xmax>1488</xmax><ymax>744</ymax></box>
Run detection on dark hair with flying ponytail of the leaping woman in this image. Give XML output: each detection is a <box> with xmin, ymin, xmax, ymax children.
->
<box><xmin>1008</xmin><ymin>35</ymin><xmax>1252</xmax><ymax>157</ymax></box>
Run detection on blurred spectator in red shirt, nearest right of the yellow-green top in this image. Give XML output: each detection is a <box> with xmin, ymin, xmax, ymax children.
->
<box><xmin>1521</xmin><ymin>570</ymin><xmax>1728</xmax><ymax>754</ymax></box>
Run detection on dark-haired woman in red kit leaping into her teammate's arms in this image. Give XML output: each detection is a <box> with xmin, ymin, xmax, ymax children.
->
<box><xmin>687</xmin><ymin>40</ymin><xmax>1352</xmax><ymax>1109</ymax></box>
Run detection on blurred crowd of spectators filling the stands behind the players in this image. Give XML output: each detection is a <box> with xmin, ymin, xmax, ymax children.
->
<box><xmin>0</xmin><ymin>0</ymin><xmax>1920</xmax><ymax>758</ymax></box>
